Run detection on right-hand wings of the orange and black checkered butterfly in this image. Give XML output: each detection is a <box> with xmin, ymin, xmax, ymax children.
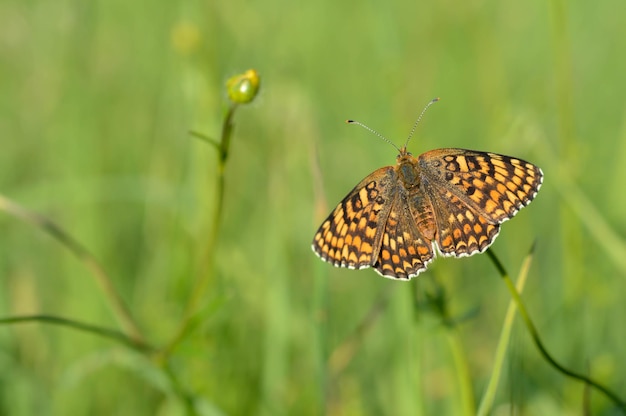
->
<box><xmin>419</xmin><ymin>149</ymin><xmax>543</xmax><ymax>256</ymax></box>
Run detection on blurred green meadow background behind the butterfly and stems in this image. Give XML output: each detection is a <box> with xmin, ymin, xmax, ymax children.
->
<box><xmin>0</xmin><ymin>0</ymin><xmax>626</xmax><ymax>415</ymax></box>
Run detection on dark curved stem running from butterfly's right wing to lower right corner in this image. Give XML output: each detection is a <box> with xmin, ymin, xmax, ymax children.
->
<box><xmin>487</xmin><ymin>249</ymin><xmax>626</xmax><ymax>414</ymax></box>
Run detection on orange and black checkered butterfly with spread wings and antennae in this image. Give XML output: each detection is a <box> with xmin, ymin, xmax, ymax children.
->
<box><xmin>312</xmin><ymin>99</ymin><xmax>543</xmax><ymax>280</ymax></box>
